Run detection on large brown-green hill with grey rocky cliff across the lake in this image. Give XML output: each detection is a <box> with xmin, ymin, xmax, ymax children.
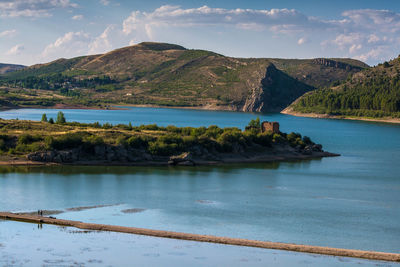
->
<box><xmin>0</xmin><ymin>42</ymin><xmax>368</xmax><ymax>112</ymax></box>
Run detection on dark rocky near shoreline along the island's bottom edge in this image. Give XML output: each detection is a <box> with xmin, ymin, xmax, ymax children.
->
<box><xmin>0</xmin><ymin>152</ymin><xmax>340</xmax><ymax>167</ymax></box>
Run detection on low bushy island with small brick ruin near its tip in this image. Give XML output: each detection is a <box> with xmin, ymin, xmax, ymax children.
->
<box><xmin>0</xmin><ymin>112</ymin><xmax>339</xmax><ymax>166</ymax></box>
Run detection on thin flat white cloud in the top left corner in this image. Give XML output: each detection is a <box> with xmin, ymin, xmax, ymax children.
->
<box><xmin>0</xmin><ymin>0</ymin><xmax>78</xmax><ymax>17</ymax></box>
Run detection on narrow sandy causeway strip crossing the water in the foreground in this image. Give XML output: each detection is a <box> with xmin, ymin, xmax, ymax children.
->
<box><xmin>0</xmin><ymin>212</ymin><xmax>400</xmax><ymax>262</ymax></box>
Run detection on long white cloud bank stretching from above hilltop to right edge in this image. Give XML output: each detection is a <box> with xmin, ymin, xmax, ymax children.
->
<box><xmin>122</xmin><ymin>5</ymin><xmax>400</xmax><ymax>64</ymax></box>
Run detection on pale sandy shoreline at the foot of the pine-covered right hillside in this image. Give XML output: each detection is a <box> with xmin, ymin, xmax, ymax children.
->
<box><xmin>280</xmin><ymin>108</ymin><xmax>400</xmax><ymax>124</ymax></box>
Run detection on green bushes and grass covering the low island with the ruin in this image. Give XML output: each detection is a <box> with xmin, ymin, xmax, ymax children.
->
<box><xmin>0</xmin><ymin>113</ymin><xmax>314</xmax><ymax>161</ymax></box>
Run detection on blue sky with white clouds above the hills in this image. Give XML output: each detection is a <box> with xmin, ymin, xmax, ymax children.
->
<box><xmin>0</xmin><ymin>0</ymin><xmax>400</xmax><ymax>65</ymax></box>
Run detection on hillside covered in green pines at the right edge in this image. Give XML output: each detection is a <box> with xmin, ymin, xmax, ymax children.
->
<box><xmin>285</xmin><ymin>56</ymin><xmax>400</xmax><ymax>118</ymax></box>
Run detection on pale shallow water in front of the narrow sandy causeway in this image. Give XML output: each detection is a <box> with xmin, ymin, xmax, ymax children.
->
<box><xmin>0</xmin><ymin>220</ymin><xmax>399</xmax><ymax>267</ymax></box>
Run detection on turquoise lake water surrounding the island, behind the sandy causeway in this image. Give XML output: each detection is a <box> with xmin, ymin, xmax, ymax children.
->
<box><xmin>0</xmin><ymin>108</ymin><xmax>400</xmax><ymax>252</ymax></box>
